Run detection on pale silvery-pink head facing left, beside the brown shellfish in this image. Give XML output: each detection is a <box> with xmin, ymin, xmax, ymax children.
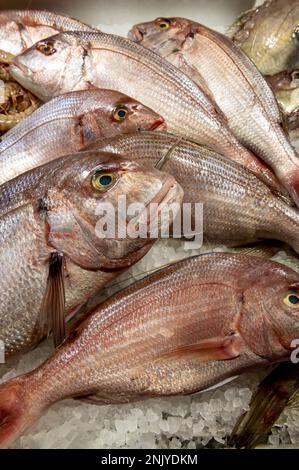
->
<box><xmin>9</xmin><ymin>33</ymin><xmax>83</xmax><ymax>101</ymax></box>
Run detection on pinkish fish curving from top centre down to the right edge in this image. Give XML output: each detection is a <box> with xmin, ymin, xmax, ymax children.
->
<box><xmin>130</xmin><ymin>18</ymin><xmax>299</xmax><ymax>206</ymax></box>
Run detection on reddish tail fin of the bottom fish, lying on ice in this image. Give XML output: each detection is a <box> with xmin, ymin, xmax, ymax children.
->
<box><xmin>0</xmin><ymin>375</ymin><xmax>42</xmax><ymax>449</ymax></box>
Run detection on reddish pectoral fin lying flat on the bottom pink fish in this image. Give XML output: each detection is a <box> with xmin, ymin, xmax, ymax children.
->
<box><xmin>155</xmin><ymin>334</ymin><xmax>241</xmax><ymax>362</ymax></box>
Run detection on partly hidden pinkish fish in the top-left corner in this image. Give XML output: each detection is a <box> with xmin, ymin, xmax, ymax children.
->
<box><xmin>0</xmin><ymin>10</ymin><xmax>95</xmax><ymax>62</ymax></box>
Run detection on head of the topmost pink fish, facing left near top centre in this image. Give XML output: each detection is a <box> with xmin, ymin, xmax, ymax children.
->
<box><xmin>128</xmin><ymin>18</ymin><xmax>192</xmax><ymax>57</ymax></box>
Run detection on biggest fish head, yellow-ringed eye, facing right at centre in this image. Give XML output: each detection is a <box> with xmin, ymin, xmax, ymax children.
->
<box><xmin>47</xmin><ymin>151</ymin><xmax>183</xmax><ymax>269</ymax></box>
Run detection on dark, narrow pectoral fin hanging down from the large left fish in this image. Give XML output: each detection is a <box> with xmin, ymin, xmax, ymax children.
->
<box><xmin>37</xmin><ymin>252</ymin><xmax>66</xmax><ymax>348</ymax></box>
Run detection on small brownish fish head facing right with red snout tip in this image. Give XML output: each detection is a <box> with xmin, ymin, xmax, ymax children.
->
<box><xmin>94</xmin><ymin>90</ymin><xmax>166</xmax><ymax>137</ymax></box>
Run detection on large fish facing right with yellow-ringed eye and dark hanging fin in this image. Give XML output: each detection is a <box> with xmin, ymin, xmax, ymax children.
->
<box><xmin>0</xmin><ymin>151</ymin><xmax>183</xmax><ymax>357</ymax></box>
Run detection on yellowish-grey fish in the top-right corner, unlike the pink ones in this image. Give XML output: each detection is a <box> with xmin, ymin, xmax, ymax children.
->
<box><xmin>228</xmin><ymin>0</ymin><xmax>299</xmax><ymax>75</ymax></box>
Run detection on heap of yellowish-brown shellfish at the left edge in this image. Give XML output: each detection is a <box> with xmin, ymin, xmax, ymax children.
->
<box><xmin>0</xmin><ymin>63</ymin><xmax>40</xmax><ymax>132</ymax></box>
